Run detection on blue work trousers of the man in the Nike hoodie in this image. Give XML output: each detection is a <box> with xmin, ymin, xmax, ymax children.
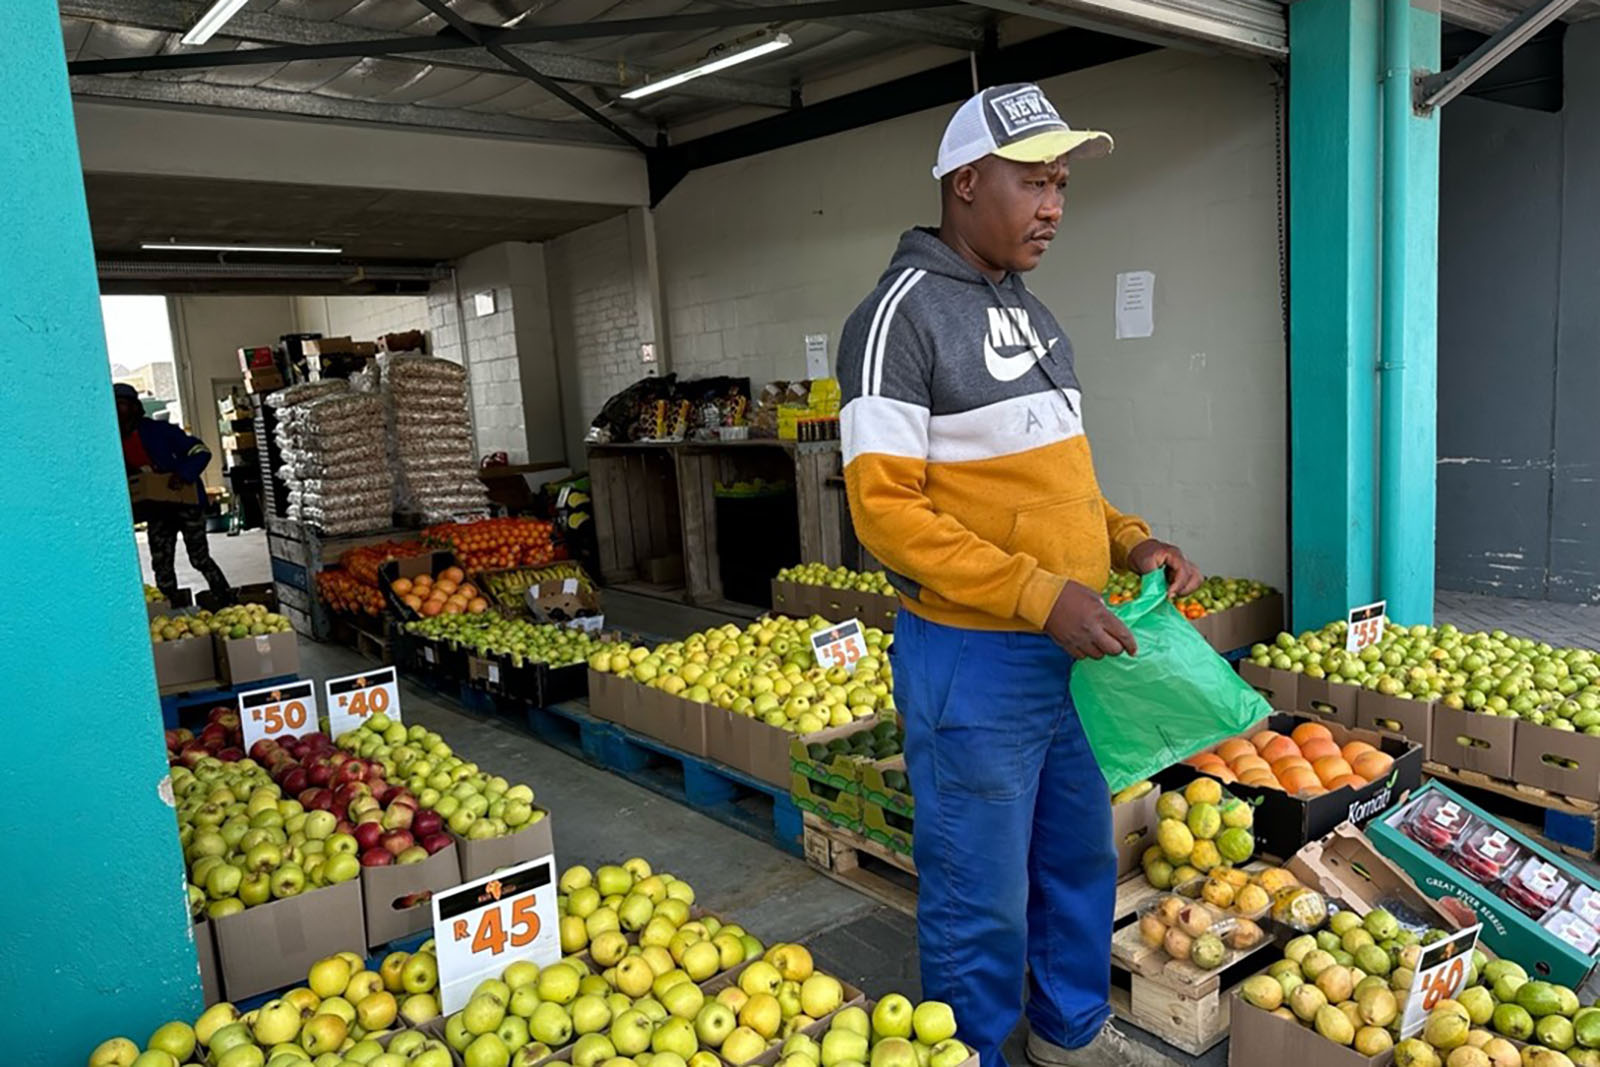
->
<box><xmin>893</xmin><ymin>611</ymin><xmax>1117</xmax><ymax>1067</ymax></box>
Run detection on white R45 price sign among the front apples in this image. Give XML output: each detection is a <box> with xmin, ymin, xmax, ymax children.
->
<box><xmin>432</xmin><ymin>856</ymin><xmax>562</xmax><ymax>1014</ymax></box>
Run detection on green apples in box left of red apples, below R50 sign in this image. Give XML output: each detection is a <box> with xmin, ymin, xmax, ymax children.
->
<box><xmin>170</xmin><ymin>757</ymin><xmax>362</xmax><ymax>918</ymax></box>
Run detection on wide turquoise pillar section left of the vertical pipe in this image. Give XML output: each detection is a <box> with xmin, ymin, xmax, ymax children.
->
<box><xmin>1288</xmin><ymin>0</ymin><xmax>1382</xmax><ymax>630</ymax></box>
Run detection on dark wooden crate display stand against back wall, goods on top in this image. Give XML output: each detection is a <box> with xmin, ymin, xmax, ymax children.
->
<box><xmin>589</xmin><ymin>440</ymin><xmax>848</xmax><ymax>605</ymax></box>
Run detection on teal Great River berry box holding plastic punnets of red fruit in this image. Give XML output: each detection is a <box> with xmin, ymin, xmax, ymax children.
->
<box><xmin>1366</xmin><ymin>781</ymin><xmax>1595</xmax><ymax>989</ymax></box>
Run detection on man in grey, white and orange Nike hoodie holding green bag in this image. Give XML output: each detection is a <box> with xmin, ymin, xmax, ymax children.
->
<box><xmin>838</xmin><ymin>85</ymin><xmax>1200</xmax><ymax>1067</ymax></box>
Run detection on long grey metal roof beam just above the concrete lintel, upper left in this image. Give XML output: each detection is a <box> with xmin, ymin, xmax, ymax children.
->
<box><xmin>72</xmin><ymin>75</ymin><xmax>633</xmax><ymax>144</ymax></box>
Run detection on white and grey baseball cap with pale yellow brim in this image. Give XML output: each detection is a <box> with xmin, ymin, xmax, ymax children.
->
<box><xmin>933</xmin><ymin>82</ymin><xmax>1112</xmax><ymax>178</ymax></box>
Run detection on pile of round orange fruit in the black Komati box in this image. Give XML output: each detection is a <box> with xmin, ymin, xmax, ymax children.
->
<box><xmin>1184</xmin><ymin>723</ymin><xmax>1394</xmax><ymax>797</ymax></box>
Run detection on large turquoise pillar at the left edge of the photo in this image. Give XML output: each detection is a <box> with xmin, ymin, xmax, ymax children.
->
<box><xmin>0</xmin><ymin>0</ymin><xmax>200</xmax><ymax>1067</ymax></box>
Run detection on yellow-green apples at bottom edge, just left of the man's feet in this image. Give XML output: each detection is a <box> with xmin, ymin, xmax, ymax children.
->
<box><xmin>806</xmin><ymin>993</ymin><xmax>971</xmax><ymax>1067</ymax></box>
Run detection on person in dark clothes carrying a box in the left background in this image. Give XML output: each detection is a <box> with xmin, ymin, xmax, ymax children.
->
<box><xmin>112</xmin><ymin>382</ymin><xmax>234</xmax><ymax>601</ymax></box>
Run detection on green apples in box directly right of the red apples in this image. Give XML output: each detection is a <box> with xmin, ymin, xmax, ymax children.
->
<box><xmin>334</xmin><ymin>713</ymin><xmax>544</xmax><ymax>841</ymax></box>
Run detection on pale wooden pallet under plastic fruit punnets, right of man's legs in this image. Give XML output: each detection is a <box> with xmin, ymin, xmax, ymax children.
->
<box><xmin>1110</xmin><ymin>872</ymin><xmax>1272</xmax><ymax>1056</ymax></box>
